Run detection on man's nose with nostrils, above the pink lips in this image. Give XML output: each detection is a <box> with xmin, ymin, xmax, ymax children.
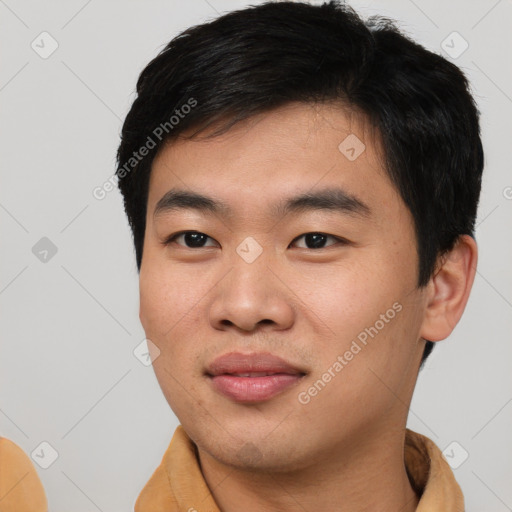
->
<box><xmin>210</xmin><ymin>251</ymin><xmax>295</xmax><ymax>331</ymax></box>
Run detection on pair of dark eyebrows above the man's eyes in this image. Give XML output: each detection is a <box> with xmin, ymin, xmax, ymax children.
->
<box><xmin>153</xmin><ymin>187</ymin><xmax>372</xmax><ymax>217</ymax></box>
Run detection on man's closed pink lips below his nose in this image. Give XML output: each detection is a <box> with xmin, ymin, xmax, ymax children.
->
<box><xmin>206</xmin><ymin>352</ymin><xmax>306</xmax><ymax>403</ymax></box>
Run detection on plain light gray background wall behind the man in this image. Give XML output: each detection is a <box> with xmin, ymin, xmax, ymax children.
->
<box><xmin>0</xmin><ymin>0</ymin><xmax>512</xmax><ymax>512</ymax></box>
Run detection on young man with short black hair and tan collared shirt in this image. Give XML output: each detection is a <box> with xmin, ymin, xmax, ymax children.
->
<box><xmin>117</xmin><ymin>2</ymin><xmax>483</xmax><ymax>512</ymax></box>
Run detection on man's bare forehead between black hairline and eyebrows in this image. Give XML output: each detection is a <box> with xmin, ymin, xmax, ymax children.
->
<box><xmin>148</xmin><ymin>104</ymin><xmax>396</xmax><ymax>218</ymax></box>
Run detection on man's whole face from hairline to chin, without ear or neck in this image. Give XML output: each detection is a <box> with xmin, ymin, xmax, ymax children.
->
<box><xmin>140</xmin><ymin>104</ymin><xmax>426</xmax><ymax>471</ymax></box>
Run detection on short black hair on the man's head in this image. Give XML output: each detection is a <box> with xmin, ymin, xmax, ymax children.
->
<box><xmin>116</xmin><ymin>0</ymin><xmax>484</xmax><ymax>364</ymax></box>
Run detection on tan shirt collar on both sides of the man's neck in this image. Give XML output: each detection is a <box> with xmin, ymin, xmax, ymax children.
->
<box><xmin>135</xmin><ymin>425</ymin><xmax>464</xmax><ymax>512</ymax></box>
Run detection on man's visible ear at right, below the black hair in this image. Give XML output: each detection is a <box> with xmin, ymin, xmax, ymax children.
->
<box><xmin>420</xmin><ymin>235</ymin><xmax>478</xmax><ymax>341</ymax></box>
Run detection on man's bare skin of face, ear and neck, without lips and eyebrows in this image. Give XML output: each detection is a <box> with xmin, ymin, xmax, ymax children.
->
<box><xmin>140</xmin><ymin>103</ymin><xmax>477</xmax><ymax>512</ymax></box>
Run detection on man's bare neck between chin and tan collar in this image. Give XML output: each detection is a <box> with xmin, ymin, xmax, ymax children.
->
<box><xmin>199</xmin><ymin>431</ymin><xmax>418</xmax><ymax>512</ymax></box>
